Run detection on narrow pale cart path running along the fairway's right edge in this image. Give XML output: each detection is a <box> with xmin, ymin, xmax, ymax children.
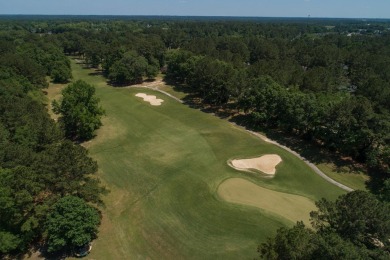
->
<box><xmin>130</xmin><ymin>82</ymin><xmax>353</xmax><ymax>192</ymax></box>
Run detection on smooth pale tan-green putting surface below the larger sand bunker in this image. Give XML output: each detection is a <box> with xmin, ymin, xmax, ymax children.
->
<box><xmin>217</xmin><ymin>178</ymin><xmax>317</xmax><ymax>226</ymax></box>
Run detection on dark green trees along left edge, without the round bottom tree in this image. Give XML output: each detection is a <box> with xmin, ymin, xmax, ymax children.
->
<box><xmin>0</xmin><ymin>35</ymin><xmax>105</xmax><ymax>258</ymax></box>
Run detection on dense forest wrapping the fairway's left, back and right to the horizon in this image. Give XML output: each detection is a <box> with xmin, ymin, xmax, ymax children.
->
<box><xmin>0</xmin><ymin>17</ymin><xmax>390</xmax><ymax>254</ymax></box>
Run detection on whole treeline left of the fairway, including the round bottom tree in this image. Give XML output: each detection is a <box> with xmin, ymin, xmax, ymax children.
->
<box><xmin>0</xmin><ymin>30</ymin><xmax>105</xmax><ymax>254</ymax></box>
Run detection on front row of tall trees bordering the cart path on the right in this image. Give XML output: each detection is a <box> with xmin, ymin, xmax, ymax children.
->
<box><xmin>166</xmin><ymin>50</ymin><xmax>390</xmax><ymax>180</ymax></box>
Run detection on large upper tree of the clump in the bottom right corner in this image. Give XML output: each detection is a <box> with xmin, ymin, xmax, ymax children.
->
<box><xmin>310</xmin><ymin>190</ymin><xmax>390</xmax><ymax>248</ymax></box>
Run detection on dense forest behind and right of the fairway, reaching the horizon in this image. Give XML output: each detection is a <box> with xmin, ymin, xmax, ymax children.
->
<box><xmin>31</xmin><ymin>17</ymin><xmax>390</xmax><ymax>192</ymax></box>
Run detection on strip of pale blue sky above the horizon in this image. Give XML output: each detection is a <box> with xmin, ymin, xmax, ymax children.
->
<box><xmin>0</xmin><ymin>0</ymin><xmax>390</xmax><ymax>18</ymax></box>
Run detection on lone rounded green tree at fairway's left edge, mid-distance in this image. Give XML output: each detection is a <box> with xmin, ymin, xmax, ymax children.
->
<box><xmin>53</xmin><ymin>80</ymin><xmax>104</xmax><ymax>140</ymax></box>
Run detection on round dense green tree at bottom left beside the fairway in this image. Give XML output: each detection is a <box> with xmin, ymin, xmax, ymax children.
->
<box><xmin>46</xmin><ymin>196</ymin><xmax>100</xmax><ymax>252</ymax></box>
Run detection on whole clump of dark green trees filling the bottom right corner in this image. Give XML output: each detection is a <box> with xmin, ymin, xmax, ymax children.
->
<box><xmin>258</xmin><ymin>191</ymin><xmax>390</xmax><ymax>259</ymax></box>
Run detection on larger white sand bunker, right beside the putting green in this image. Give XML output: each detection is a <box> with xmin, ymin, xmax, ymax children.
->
<box><xmin>229</xmin><ymin>154</ymin><xmax>282</xmax><ymax>175</ymax></box>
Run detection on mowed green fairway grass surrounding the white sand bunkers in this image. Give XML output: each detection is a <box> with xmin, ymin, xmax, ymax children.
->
<box><xmin>68</xmin><ymin>62</ymin><xmax>343</xmax><ymax>259</ymax></box>
